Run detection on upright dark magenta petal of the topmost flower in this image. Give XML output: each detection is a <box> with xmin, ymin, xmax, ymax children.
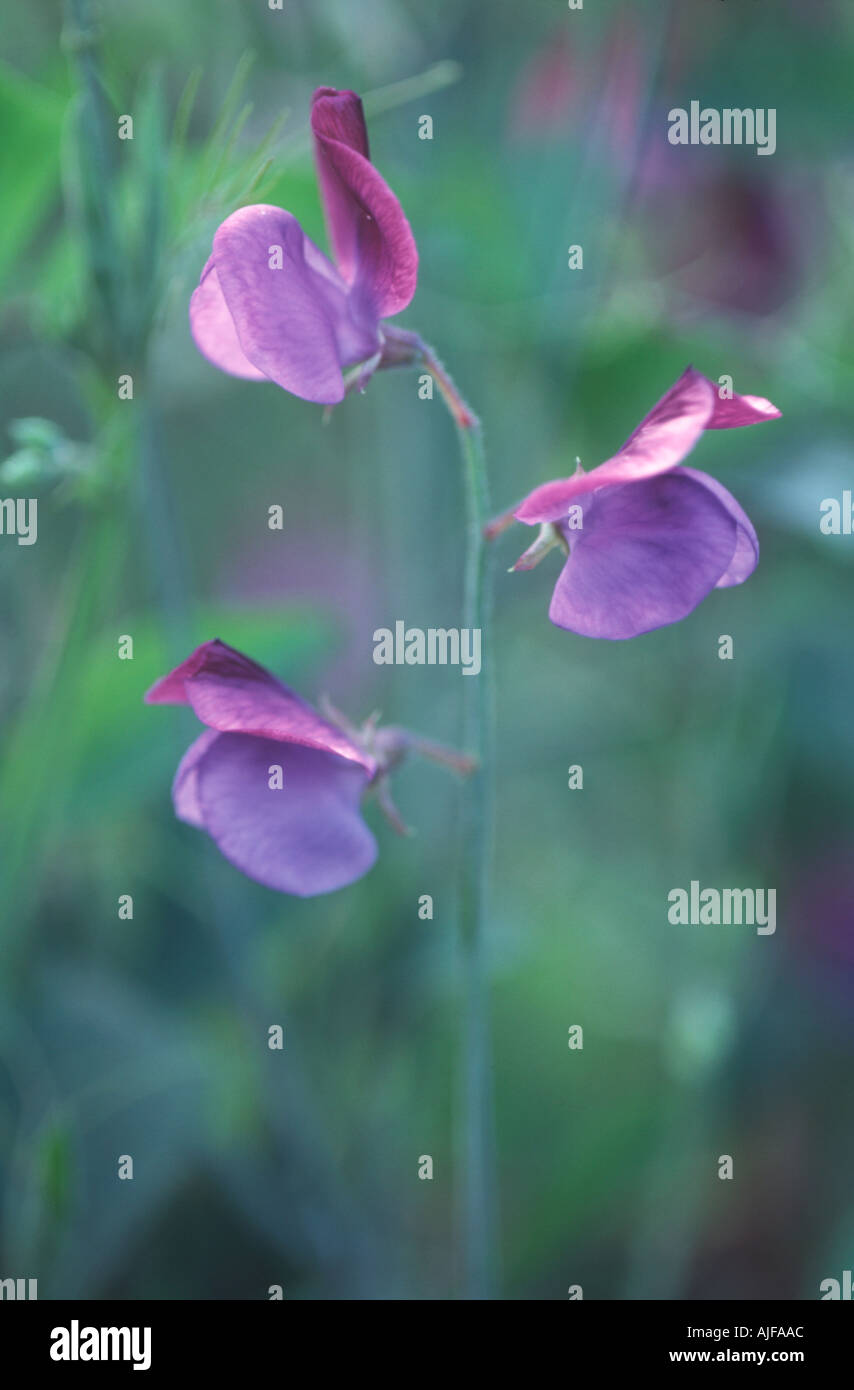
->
<box><xmin>312</xmin><ymin>88</ymin><xmax>419</xmax><ymax>318</ymax></box>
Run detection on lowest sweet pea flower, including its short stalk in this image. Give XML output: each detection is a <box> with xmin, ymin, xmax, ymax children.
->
<box><xmin>145</xmin><ymin>639</ymin><xmax>473</xmax><ymax>898</ymax></box>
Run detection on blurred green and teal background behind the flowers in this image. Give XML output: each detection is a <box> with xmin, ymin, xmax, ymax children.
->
<box><xmin>0</xmin><ymin>0</ymin><xmax>854</xmax><ymax>1300</ymax></box>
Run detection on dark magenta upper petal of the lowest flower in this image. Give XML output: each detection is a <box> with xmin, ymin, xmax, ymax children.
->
<box><xmin>145</xmin><ymin>639</ymin><xmax>377</xmax><ymax>777</ymax></box>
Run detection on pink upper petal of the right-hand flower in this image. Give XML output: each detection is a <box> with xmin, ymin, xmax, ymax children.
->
<box><xmin>513</xmin><ymin>367</ymin><xmax>780</xmax><ymax>525</ymax></box>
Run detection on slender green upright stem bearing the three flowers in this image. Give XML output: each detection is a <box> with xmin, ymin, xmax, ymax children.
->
<box><xmin>419</xmin><ymin>343</ymin><xmax>498</xmax><ymax>1300</ymax></box>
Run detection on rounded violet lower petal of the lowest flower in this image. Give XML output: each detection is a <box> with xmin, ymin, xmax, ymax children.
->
<box><xmin>196</xmin><ymin>734</ymin><xmax>377</xmax><ymax>898</ymax></box>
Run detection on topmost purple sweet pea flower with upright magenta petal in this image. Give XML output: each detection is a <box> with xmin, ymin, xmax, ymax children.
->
<box><xmin>189</xmin><ymin>88</ymin><xmax>419</xmax><ymax>406</ymax></box>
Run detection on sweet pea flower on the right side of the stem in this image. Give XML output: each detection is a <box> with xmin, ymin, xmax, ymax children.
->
<box><xmin>487</xmin><ymin>367</ymin><xmax>780</xmax><ymax>641</ymax></box>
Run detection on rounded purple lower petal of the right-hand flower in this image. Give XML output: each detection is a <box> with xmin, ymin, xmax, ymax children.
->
<box><xmin>548</xmin><ymin>470</ymin><xmax>739</xmax><ymax>641</ymax></box>
